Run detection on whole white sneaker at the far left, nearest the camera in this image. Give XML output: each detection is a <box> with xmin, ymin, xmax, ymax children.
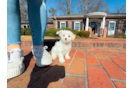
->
<box><xmin>7</xmin><ymin>49</ymin><xmax>25</xmax><ymax>79</ymax></box>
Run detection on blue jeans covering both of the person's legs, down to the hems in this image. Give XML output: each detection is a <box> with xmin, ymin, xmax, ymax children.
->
<box><xmin>7</xmin><ymin>0</ymin><xmax>47</xmax><ymax>45</ymax></box>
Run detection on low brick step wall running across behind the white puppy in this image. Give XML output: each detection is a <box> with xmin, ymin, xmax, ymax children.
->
<box><xmin>21</xmin><ymin>40</ymin><xmax>126</xmax><ymax>49</ymax></box>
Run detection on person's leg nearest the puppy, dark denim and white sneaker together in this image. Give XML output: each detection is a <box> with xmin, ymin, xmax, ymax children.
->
<box><xmin>27</xmin><ymin>0</ymin><xmax>52</xmax><ymax>67</ymax></box>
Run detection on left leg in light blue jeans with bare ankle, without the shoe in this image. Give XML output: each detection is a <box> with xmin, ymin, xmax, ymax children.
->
<box><xmin>7</xmin><ymin>0</ymin><xmax>21</xmax><ymax>50</ymax></box>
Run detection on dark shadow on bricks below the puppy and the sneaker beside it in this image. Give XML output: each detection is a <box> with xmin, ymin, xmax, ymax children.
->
<box><xmin>28</xmin><ymin>65</ymin><xmax>65</xmax><ymax>88</ymax></box>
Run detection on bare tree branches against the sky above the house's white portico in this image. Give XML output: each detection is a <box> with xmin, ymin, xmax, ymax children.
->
<box><xmin>77</xmin><ymin>0</ymin><xmax>108</xmax><ymax>13</ymax></box>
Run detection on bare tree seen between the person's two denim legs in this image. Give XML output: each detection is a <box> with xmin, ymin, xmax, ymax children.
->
<box><xmin>20</xmin><ymin>0</ymin><xmax>28</xmax><ymax>20</ymax></box>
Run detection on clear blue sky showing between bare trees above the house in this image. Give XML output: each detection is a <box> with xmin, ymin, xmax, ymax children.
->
<box><xmin>46</xmin><ymin>0</ymin><xmax>126</xmax><ymax>15</ymax></box>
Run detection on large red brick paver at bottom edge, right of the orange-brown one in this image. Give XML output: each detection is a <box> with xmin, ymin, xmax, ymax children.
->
<box><xmin>87</xmin><ymin>66</ymin><xmax>114</xmax><ymax>88</ymax></box>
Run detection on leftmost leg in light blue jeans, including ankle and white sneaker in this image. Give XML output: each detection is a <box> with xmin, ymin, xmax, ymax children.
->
<box><xmin>7</xmin><ymin>0</ymin><xmax>25</xmax><ymax>79</ymax></box>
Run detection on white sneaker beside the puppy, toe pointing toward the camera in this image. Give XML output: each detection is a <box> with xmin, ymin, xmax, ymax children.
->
<box><xmin>32</xmin><ymin>46</ymin><xmax>52</xmax><ymax>67</ymax></box>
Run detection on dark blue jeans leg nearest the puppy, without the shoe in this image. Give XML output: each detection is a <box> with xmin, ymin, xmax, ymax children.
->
<box><xmin>28</xmin><ymin>0</ymin><xmax>47</xmax><ymax>46</ymax></box>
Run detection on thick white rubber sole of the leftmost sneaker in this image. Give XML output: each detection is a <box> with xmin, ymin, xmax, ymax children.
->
<box><xmin>7</xmin><ymin>57</ymin><xmax>25</xmax><ymax>79</ymax></box>
